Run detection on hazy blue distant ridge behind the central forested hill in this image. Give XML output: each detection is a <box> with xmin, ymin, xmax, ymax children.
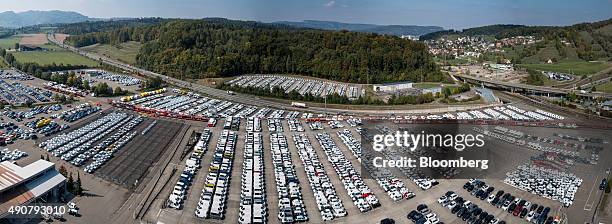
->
<box><xmin>274</xmin><ymin>20</ymin><xmax>444</xmax><ymax>36</ymax></box>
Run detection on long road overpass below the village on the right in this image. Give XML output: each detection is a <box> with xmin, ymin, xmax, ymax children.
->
<box><xmin>453</xmin><ymin>74</ymin><xmax>612</xmax><ymax>99</ymax></box>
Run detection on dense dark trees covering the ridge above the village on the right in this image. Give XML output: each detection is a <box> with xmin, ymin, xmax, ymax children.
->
<box><xmin>421</xmin><ymin>19</ymin><xmax>612</xmax><ymax>61</ymax></box>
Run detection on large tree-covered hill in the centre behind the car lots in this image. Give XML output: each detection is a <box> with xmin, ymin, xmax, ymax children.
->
<box><xmin>67</xmin><ymin>19</ymin><xmax>446</xmax><ymax>83</ymax></box>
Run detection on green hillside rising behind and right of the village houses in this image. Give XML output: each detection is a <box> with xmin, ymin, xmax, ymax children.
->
<box><xmin>421</xmin><ymin>19</ymin><xmax>612</xmax><ymax>63</ymax></box>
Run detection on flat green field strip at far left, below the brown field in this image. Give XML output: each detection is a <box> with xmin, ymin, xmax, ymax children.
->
<box><xmin>13</xmin><ymin>50</ymin><xmax>98</xmax><ymax>67</ymax></box>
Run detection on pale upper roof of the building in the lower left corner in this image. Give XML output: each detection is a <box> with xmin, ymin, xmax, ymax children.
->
<box><xmin>0</xmin><ymin>159</ymin><xmax>54</xmax><ymax>192</ymax></box>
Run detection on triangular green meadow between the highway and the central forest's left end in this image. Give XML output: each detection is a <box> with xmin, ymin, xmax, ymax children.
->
<box><xmin>81</xmin><ymin>41</ymin><xmax>142</xmax><ymax>64</ymax></box>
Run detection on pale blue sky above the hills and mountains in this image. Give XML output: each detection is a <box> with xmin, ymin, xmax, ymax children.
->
<box><xmin>0</xmin><ymin>0</ymin><xmax>612</xmax><ymax>29</ymax></box>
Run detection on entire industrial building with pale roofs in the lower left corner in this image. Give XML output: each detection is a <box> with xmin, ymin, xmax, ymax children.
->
<box><xmin>0</xmin><ymin>160</ymin><xmax>66</xmax><ymax>219</ymax></box>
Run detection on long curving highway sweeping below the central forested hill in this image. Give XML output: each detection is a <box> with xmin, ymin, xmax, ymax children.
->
<box><xmin>47</xmin><ymin>33</ymin><xmax>502</xmax><ymax>115</ymax></box>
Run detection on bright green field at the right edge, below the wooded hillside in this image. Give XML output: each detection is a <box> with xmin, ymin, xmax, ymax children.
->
<box><xmin>518</xmin><ymin>61</ymin><xmax>610</xmax><ymax>75</ymax></box>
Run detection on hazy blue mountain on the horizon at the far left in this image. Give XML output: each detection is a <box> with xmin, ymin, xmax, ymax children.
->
<box><xmin>0</xmin><ymin>10</ymin><xmax>95</xmax><ymax>28</ymax></box>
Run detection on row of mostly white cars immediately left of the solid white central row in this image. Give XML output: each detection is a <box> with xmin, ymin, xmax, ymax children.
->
<box><xmin>195</xmin><ymin>130</ymin><xmax>238</xmax><ymax>219</ymax></box>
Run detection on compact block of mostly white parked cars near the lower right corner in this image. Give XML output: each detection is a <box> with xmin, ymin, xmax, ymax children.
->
<box><xmin>504</xmin><ymin>164</ymin><xmax>582</xmax><ymax>207</ymax></box>
